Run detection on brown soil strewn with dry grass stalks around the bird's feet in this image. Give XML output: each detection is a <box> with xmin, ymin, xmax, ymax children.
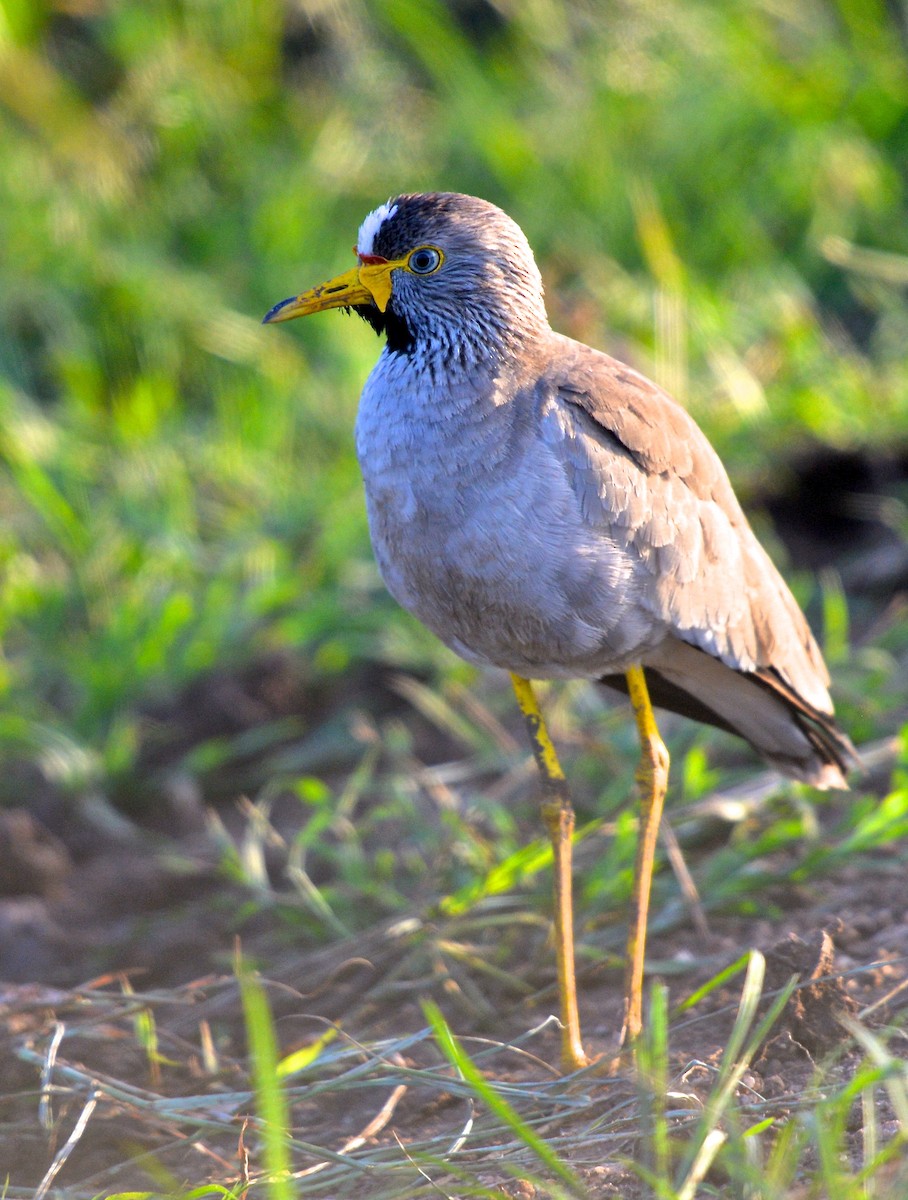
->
<box><xmin>0</xmin><ymin>446</ymin><xmax>908</xmax><ymax>1198</ymax></box>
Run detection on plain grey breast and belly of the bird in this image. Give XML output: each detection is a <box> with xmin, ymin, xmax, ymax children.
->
<box><xmin>356</xmin><ymin>355</ymin><xmax>663</xmax><ymax>678</ymax></box>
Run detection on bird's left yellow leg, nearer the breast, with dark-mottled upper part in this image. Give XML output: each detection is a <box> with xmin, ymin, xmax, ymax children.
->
<box><xmin>511</xmin><ymin>674</ymin><xmax>589</xmax><ymax>1070</ymax></box>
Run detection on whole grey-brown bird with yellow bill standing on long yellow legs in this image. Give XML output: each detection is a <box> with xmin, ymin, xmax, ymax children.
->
<box><xmin>264</xmin><ymin>192</ymin><xmax>858</xmax><ymax>1072</ymax></box>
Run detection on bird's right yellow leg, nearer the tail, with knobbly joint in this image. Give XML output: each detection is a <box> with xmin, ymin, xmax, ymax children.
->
<box><xmin>621</xmin><ymin>666</ymin><xmax>668</xmax><ymax>1045</ymax></box>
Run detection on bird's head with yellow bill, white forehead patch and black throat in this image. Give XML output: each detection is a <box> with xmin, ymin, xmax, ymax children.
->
<box><xmin>265</xmin><ymin>192</ymin><xmax>547</xmax><ymax>354</ymax></box>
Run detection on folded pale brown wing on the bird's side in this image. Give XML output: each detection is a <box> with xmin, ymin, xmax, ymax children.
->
<box><xmin>546</xmin><ymin>338</ymin><xmax>832</xmax><ymax>714</ymax></box>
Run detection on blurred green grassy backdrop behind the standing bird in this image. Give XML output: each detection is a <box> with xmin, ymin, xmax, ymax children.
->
<box><xmin>0</xmin><ymin>0</ymin><xmax>908</xmax><ymax>883</ymax></box>
